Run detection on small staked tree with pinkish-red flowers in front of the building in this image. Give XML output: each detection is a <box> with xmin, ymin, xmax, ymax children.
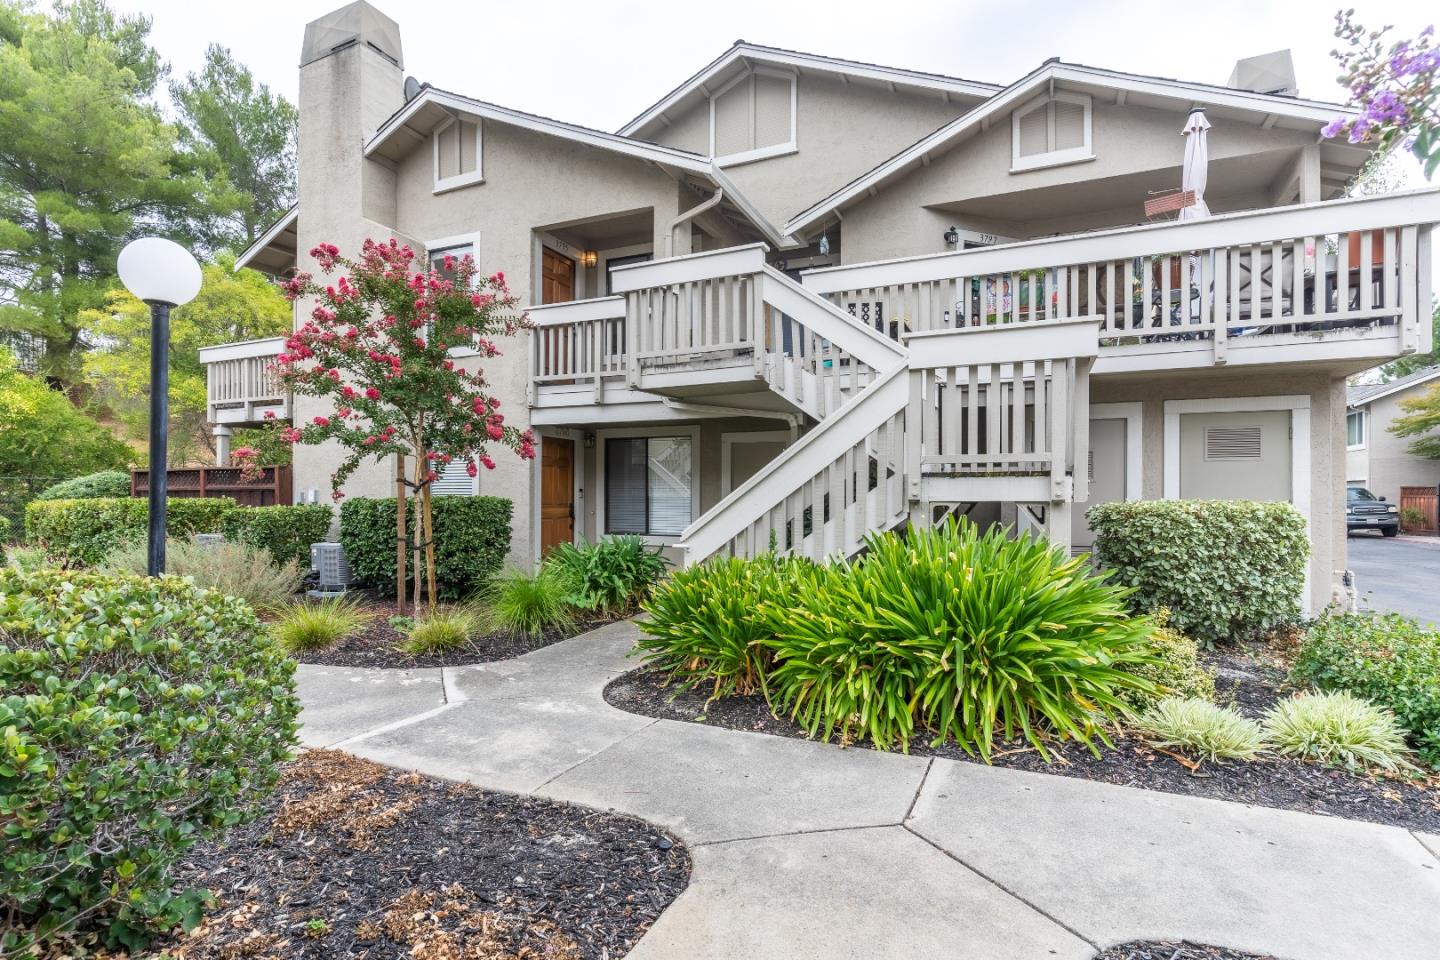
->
<box><xmin>271</xmin><ymin>239</ymin><xmax>536</xmax><ymax>603</ymax></box>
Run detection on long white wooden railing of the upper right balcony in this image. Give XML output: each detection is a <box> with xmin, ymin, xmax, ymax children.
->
<box><xmin>804</xmin><ymin>190</ymin><xmax>1440</xmax><ymax>371</ymax></box>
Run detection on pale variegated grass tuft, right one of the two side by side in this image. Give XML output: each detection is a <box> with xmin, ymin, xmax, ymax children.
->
<box><xmin>1264</xmin><ymin>692</ymin><xmax>1411</xmax><ymax>770</ymax></box>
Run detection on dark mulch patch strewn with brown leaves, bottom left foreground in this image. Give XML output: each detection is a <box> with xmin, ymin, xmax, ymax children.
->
<box><xmin>154</xmin><ymin>750</ymin><xmax>690</xmax><ymax>960</ymax></box>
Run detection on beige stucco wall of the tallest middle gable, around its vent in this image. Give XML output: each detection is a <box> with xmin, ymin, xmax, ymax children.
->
<box><xmin>657</xmin><ymin>73</ymin><xmax>965</xmax><ymax>225</ymax></box>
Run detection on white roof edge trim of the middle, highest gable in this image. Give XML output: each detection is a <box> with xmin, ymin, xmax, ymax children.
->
<box><xmin>619</xmin><ymin>40</ymin><xmax>1001</xmax><ymax>137</ymax></box>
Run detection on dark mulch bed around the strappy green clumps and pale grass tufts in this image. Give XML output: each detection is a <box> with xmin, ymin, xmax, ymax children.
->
<box><xmin>605</xmin><ymin>646</ymin><xmax>1440</xmax><ymax>834</ymax></box>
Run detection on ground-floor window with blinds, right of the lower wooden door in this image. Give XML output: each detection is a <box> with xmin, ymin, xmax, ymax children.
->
<box><xmin>605</xmin><ymin>436</ymin><xmax>696</xmax><ymax>537</ymax></box>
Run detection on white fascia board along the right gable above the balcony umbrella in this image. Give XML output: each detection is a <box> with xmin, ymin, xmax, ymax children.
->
<box><xmin>783</xmin><ymin>63</ymin><xmax>1354</xmax><ymax>235</ymax></box>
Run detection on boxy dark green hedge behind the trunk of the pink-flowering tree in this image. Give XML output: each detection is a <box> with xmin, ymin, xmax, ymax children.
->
<box><xmin>340</xmin><ymin>497</ymin><xmax>514</xmax><ymax>600</ymax></box>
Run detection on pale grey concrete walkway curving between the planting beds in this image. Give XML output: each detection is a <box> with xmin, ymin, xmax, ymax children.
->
<box><xmin>300</xmin><ymin>623</ymin><xmax>1440</xmax><ymax>960</ymax></box>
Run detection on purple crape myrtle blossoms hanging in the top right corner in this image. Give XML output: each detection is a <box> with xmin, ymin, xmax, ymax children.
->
<box><xmin>1322</xmin><ymin>10</ymin><xmax>1440</xmax><ymax>177</ymax></box>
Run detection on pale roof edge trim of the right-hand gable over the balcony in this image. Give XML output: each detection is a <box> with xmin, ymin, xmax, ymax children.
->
<box><xmin>783</xmin><ymin>60</ymin><xmax>1352</xmax><ymax>235</ymax></box>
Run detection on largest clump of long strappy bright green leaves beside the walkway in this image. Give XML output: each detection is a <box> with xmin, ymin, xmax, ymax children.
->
<box><xmin>760</xmin><ymin>520</ymin><xmax>1151</xmax><ymax>760</ymax></box>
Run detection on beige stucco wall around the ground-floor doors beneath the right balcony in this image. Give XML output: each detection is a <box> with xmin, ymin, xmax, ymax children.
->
<box><xmin>1090</xmin><ymin>370</ymin><xmax>1345</xmax><ymax>610</ymax></box>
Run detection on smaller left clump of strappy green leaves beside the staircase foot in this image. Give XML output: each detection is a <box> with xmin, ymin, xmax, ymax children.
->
<box><xmin>635</xmin><ymin>554</ymin><xmax>805</xmax><ymax>699</ymax></box>
